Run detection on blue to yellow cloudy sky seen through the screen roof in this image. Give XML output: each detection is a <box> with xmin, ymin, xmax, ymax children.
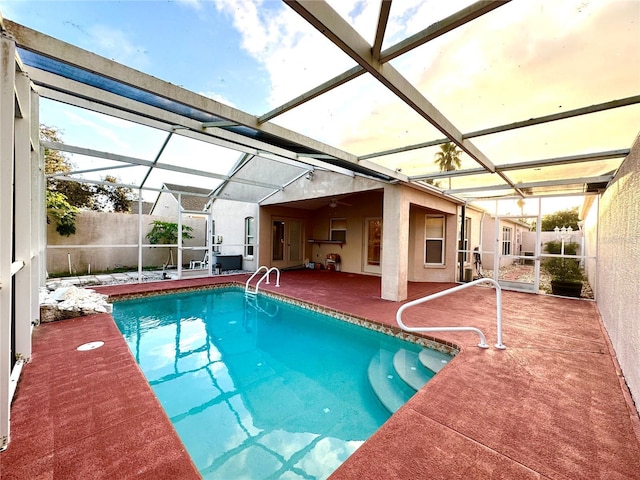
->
<box><xmin>0</xmin><ymin>0</ymin><xmax>640</xmax><ymax>212</ymax></box>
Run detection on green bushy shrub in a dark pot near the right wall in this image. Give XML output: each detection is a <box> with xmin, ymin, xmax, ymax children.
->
<box><xmin>542</xmin><ymin>241</ymin><xmax>585</xmax><ymax>297</ymax></box>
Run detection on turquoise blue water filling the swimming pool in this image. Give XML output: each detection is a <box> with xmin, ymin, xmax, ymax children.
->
<box><xmin>113</xmin><ymin>289</ymin><xmax>446</xmax><ymax>480</ymax></box>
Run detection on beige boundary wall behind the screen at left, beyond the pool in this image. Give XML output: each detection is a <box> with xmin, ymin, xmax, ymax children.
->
<box><xmin>47</xmin><ymin>212</ymin><xmax>206</xmax><ymax>274</ymax></box>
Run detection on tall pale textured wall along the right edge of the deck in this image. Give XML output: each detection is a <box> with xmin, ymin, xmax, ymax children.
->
<box><xmin>587</xmin><ymin>136</ymin><xmax>640</xmax><ymax>405</ymax></box>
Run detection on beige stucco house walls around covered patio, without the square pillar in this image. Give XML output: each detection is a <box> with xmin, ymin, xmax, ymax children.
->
<box><xmin>259</xmin><ymin>171</ymin><xmax>458</xmax><ymax>282</ymax></box>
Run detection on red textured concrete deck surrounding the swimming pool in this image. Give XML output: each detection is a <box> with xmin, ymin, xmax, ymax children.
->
<box><xmin>0</xmin><ymin>270</ymin><xmax>640</xmax><ymax>479</ymax></box>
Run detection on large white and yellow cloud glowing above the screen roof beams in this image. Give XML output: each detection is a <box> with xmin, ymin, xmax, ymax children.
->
<box><xmin>217</xmin><ymin>0</ymin><xmax>640</xmax><ymax>178</ymax></box>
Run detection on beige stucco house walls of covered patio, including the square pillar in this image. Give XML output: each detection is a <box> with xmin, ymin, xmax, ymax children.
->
<box><xmin>259</xmin><ymin>178</ymin><xmax>462</xmax><ymax>298</ymax></box>
